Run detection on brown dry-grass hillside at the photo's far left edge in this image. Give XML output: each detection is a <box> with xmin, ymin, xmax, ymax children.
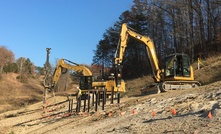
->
<box><xmin>0</xmin><ymin>73</ymin><xmax>43</xmax><ymax>113</ymax></box>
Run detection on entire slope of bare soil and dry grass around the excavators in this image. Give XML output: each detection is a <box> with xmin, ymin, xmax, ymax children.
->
<box><xmin>0</xmin><ymin>56</ymin><xmax>221</xmax><ymax>134</ymax></box>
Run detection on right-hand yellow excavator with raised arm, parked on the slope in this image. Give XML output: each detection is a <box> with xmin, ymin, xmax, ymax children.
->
<box><xmin>114</xmin><ymin>23</ymin><xmax>200</xmax><ymax>92</ymax></box>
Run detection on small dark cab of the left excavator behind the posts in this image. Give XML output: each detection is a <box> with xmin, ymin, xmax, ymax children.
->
<box><xmin>79</xmin><ymin>76</ymin><xmax>93</xmax><ymax>90</ymax></box>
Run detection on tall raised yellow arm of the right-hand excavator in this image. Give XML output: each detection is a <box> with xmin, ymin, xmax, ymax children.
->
<box><xmin>115</xmin><ymin>23</ymin><xmax>162</xmax><ymax>86</ymax></box>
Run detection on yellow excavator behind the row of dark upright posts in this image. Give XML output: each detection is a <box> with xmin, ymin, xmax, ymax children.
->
<box><xmin>50</xmin><ymin>59</ymin><xmax>125</xmax><ymax>94</ymax></box>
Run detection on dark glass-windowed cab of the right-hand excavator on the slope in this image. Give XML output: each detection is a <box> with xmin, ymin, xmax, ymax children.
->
<box><xmin>164</xmin><ymin>53</ymin><xmax>191</xmax><ymax>80</ymax></box>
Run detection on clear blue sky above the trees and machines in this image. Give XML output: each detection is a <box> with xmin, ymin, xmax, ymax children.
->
<box><xmin>0</xmin><ymin>0</ymin><xmax>133</xmax><ymax>67</ymax></box>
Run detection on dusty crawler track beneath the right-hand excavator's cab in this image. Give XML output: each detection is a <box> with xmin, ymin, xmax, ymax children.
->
<box><xmin>158</xmin><ymin>81</ymin><xmax>201</xmax><ymax>92</ymax></box>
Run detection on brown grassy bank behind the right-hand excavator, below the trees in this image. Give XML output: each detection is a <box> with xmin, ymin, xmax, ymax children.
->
<box><xmin>123</xmin><ymin>55</ymin><xmax>221</xmax><ymax>97</ymax></box>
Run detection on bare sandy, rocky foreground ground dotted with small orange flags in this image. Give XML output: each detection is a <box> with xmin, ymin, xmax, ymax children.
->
<box><xmin>0</xmin><ymin>81</ymin><xmax>221</xmax><ymax>134</ymax></box>
